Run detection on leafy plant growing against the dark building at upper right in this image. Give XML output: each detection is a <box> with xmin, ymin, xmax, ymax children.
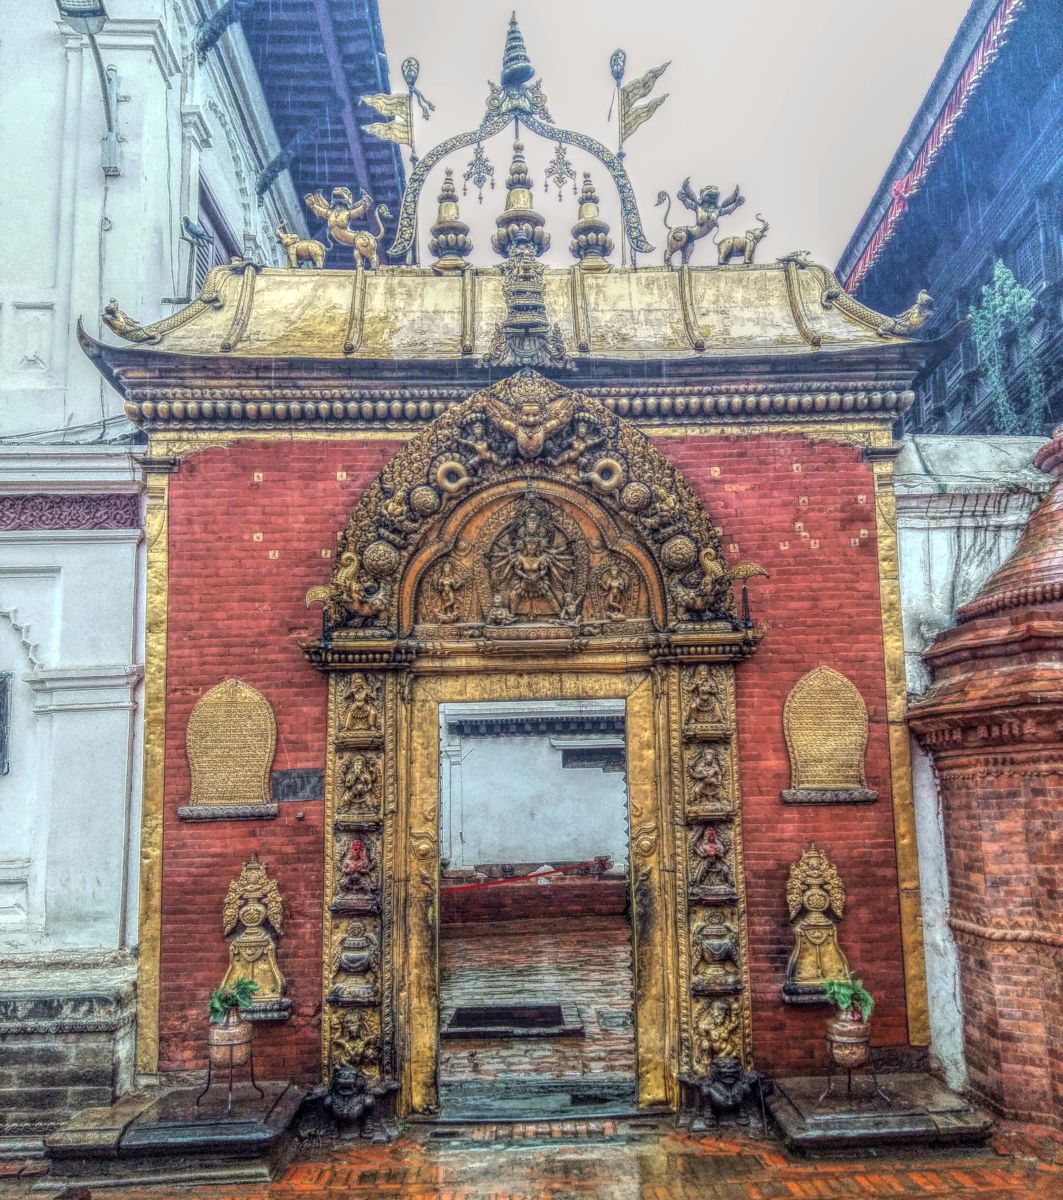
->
<box><xmin>969</xmin><ymin>259</ymin><xmax>1047</xmax><ymax>433</ymax></box>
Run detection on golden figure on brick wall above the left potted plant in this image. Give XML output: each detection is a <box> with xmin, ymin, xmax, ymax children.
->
<box><xmin>221</xmin><ymin>853</ymin><xmax>284</xmax><ymax>1004</ymax></box>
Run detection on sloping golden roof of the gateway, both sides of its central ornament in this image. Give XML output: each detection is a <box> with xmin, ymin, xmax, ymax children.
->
<box><xmin>97</xmin><ymin>260</ymin><xmax>914</xmax><ymax>364</ymax></box>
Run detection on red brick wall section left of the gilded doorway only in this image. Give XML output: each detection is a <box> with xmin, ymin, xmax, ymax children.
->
<box><xmin>160</xmin><ymin>439</ymin><xmax>396</xmax><ymax>1081</ymax></box>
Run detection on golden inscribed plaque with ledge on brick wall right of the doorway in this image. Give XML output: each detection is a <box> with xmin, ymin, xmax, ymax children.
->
<box><xmin>782</xmin><ymin>667</ymin><xmax>878</xmax><ymax>804</ymax></box>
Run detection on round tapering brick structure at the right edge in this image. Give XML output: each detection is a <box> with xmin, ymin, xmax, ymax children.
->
<box><xmin>911</xmin><ymin>430</ymin><xmax>1063</xmax><ymax>1127</ymax></box>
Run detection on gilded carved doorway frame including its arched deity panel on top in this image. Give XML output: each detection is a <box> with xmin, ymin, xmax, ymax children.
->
<box><xmin>304</xmin><ymin>372</ymin><xmax>763</xmax><ymax>1114</ymax></box>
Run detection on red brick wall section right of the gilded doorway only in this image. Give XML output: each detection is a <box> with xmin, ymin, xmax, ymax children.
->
<box><xmin>656</xmin><ymin>436</ymin><xmax>907</xmax><ymax>1074</ymax></box>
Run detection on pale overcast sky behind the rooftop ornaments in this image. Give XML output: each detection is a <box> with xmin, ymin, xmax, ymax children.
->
<box><xmin>380</xmin><ymin>0</ymin><xmax>968</xmax><ymax>266</ymax></box>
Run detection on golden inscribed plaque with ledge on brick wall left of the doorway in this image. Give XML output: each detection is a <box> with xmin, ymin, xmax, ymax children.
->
<box><xmin>178</xmin><ymin>679</ymin><xmax>277</xmax><ymax>821</ymax></box>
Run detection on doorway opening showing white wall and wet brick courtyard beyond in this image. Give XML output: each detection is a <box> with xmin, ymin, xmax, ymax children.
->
<box><xmin>438</xmin><ymin>700</ymin><xmax>637</xmax><ymax>1118</ymax></box>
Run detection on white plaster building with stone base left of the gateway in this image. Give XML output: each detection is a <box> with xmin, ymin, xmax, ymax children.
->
<box><xmin>0</xmin><ymin>0</ymin><xmax>305</xmax><ymax>1154</ymax></box>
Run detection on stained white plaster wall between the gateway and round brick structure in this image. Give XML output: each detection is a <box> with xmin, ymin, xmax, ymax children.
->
<box><xmin>895</xmin><ymin>434</ymin><xmax>1051</xmax><ymax>1088</ymax></box>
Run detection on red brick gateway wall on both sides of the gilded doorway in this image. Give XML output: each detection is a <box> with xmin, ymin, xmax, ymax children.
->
<box><xmin>160</xmin><ymin>436</ymin><xmax>907</xmax><ymax>1080</ymax></box>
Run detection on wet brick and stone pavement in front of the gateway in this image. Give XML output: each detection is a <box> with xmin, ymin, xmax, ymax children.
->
<box><xmin>8</xmin><ymin>1121</ymin><xmax>1063</xmax><ymax>1200</ymax></box>
